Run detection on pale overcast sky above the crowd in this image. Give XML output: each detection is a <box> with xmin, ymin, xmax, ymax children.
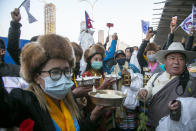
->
<box><xmin>0</xmin><ymin>0</ymin><xmax>163</xmax><ymax>46</ymax></box>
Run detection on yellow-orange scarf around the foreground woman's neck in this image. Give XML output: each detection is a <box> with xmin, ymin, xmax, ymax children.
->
<box><xmin>46</xmin><ymin>96</ymin><xmax>75</xmax><ymax>131</ymax></box>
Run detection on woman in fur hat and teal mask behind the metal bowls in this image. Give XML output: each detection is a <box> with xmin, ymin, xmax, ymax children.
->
<box><xmin>82</xmin><ymin>43</ymin><xmax>115</xmax><ymax>131</ymax></box>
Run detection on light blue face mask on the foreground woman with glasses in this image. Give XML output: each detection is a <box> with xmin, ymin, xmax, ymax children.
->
<box><xmin>43</xmin><ymin>75</ymin><xmax>74</xmax><ymax>100</ymax></box>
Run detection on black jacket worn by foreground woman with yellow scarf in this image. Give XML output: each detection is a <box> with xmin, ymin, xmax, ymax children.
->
<box><xmin>0</xmin><ymin>78</ymin><xmax>98</xmax><ymax>131</ymax></box>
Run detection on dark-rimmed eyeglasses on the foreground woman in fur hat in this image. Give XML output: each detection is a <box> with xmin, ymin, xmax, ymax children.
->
<box><xmin>40</xmin><ymin>68</ymin><xmax>72</xmax><ymax>81</ymax></box>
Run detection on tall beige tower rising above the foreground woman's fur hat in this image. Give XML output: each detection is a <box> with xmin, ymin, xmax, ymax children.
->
<box><xmin>44</xmin><ymin>3</ymin><xmax>56</xmax><ymax>34</ymax></box>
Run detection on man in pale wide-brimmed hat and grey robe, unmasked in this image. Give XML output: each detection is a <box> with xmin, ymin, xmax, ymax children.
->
<box><xmin>138</xmin><ymin>42</ymin><xmax>196</xmax><ymax>129</ymax></box>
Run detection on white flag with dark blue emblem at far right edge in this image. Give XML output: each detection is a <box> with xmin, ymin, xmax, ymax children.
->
<box><xmin>180</xmin><ymin>13</ymin><xmax>196</xmax><ymax>34</ymax></box>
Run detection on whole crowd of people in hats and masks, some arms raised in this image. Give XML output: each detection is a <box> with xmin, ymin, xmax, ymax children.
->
<box><xmin>0</xmin><ymin>9</ymin><xmax>196</xmax><ymax>131</ymax></box>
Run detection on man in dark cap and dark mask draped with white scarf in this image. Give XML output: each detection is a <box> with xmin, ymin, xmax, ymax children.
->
<box><xmin>111</xmin><ymin>50</ymin><xmax>143</xmax><ymax>130</ymax></box>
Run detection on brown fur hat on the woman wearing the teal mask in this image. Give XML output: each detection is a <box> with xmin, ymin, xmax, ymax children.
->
<box><xmin>84</xmin><ymin>43</ymin><xmax>105</xmax><ymax>62</ymax></box>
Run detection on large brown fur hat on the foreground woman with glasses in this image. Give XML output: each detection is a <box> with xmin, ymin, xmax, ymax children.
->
<box><xmin>20</xmin><ymin>34</ymin><xmax>75</xmax><ymax>83</ymax></box>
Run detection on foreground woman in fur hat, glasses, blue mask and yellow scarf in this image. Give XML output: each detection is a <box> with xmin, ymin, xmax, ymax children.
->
<box><xmin>0</xmin><ymin>34</ymin><xmax>106</xmax><ymax>131</ymax></box>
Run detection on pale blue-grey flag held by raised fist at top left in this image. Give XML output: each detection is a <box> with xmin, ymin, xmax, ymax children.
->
<box><xmin>22</xmin><ymin>0</ymin><xmax>37</xmax><ymax>24</ymax></box>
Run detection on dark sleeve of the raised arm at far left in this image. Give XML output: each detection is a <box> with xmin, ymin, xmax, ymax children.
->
<box><xmin>7</xmin><ymin>21</ymin><xmax>22</xmax><ymax>65</ymax></box>
